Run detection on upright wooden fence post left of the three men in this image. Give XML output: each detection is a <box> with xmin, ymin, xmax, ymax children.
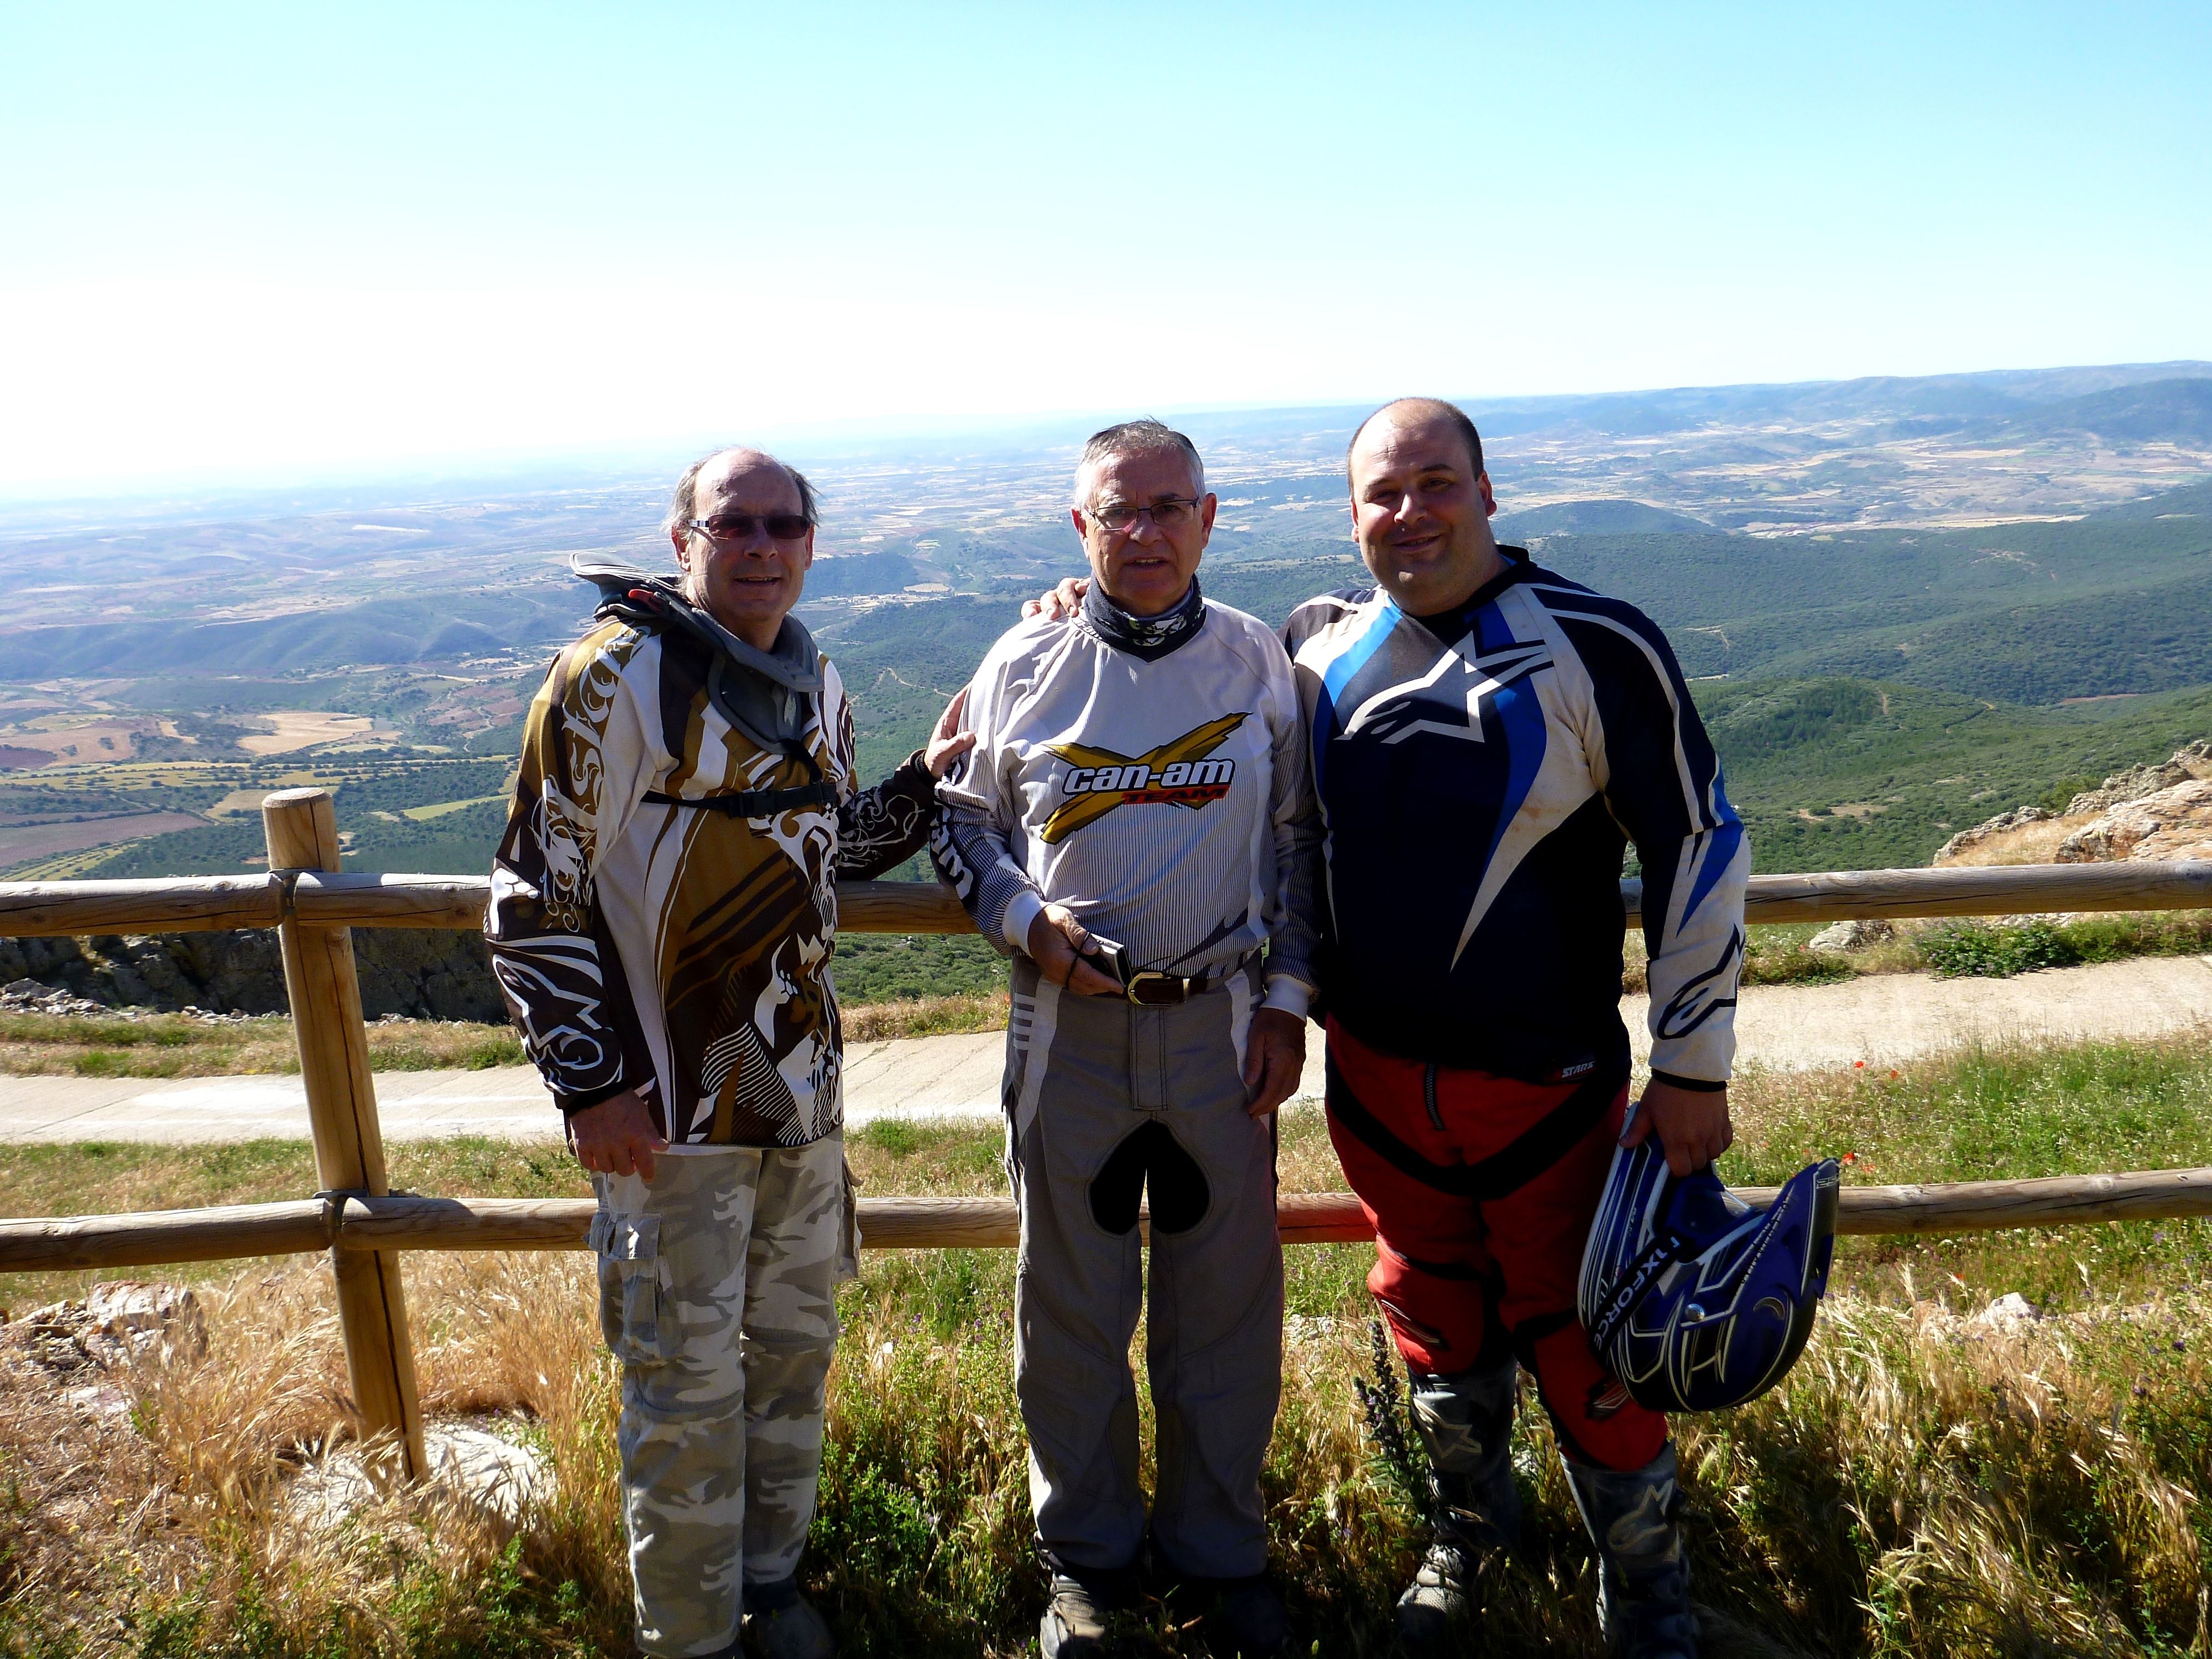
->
<box><xmin>261</xmin><ymin>790</ymin><xmax>429</xmax><ymax>1480</ymax></box>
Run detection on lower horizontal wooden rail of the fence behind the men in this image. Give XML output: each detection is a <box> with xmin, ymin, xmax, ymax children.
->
<box><xmin>13</xmin><ymin>1168</ymin><xmax>2212</xmax><ymax>1272</ymax></box>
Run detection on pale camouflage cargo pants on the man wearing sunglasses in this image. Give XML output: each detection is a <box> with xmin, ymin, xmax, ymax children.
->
<box><xmin>591</xmin><ymin>1135</ymin><xmax>858</xmax><ymax>1659</ymax></box>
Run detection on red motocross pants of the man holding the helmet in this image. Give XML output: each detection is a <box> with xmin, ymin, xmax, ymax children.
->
<box><xmin>1327</xmin><ymin>1020</ymin><xmax>1666</xmax><ymax>1471</ymax></box>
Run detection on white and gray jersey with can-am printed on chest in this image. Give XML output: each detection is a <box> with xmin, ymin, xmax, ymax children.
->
<box><xmin>931</xmin><ymin>599</ymin><xmax>1321</xmax><ymax>1011</ymax></box>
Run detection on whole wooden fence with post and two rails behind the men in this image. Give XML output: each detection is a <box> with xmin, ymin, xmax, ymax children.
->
<box><xmin>0</xmin><ymin>790</ymin><xmax>2212</xmax><ymax>1475</ymax></box>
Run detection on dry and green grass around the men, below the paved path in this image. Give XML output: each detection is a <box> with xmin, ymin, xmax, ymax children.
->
<box><xmin>0</xmin><ymin>1033</ymin><xmax>2212</xmax><ymax>1659</ymax></box>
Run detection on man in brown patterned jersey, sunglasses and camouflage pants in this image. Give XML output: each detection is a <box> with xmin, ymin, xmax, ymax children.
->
<box><xmin>484</xmin><ymin>449</ymin><xmax>967</xmax><ymax>1659</ymax></box>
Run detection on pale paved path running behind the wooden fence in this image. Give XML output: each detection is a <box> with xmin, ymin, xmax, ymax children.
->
<box><xmin>0</xmin><ymin>956</ymin><xmax>2212</xmax><ymax>1144</ymax></box>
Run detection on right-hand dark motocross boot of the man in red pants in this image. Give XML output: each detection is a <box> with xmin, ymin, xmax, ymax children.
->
<box><xmin>1566</xmin><ymin>1440</ymin><xmax>1697</xmax><ymax>1659</ymax></box>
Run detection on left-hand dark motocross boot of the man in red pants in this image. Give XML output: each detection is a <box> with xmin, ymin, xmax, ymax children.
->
<box><xmin>1398</xmin><ymin>1358</ymin><xmax>1520</xmax><ymax>1655</ymax></box>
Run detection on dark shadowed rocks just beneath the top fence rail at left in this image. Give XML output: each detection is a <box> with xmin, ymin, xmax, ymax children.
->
<box><xmin>0</xmin><ymin>927</ymin><xmax>507</xmax><ymax>1022</ymax></box>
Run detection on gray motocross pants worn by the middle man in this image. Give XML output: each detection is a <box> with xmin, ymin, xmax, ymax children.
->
<box><xmin>1002</xmin><ymin>958</ymin><xmax>1283</xmax><ymax>1577</ymax></box>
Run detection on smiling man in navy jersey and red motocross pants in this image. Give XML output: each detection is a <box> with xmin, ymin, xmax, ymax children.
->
<box><xmin>1285</xmin><ymin>398</ymin><xmax>1750</xmax><ymax>1659</ymax></box>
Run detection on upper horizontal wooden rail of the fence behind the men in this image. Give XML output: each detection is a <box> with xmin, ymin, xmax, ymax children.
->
<box><xmin>0</xmin><ymin>860</ymin><xmax>2212</xmax><ymax>938</ymax></box>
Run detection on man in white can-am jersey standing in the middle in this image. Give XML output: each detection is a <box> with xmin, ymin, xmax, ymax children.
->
<box><xmin>931</xmin><ymin>420</ymin><xmax>1318</xmax><ymax>1659</ymax></box>
